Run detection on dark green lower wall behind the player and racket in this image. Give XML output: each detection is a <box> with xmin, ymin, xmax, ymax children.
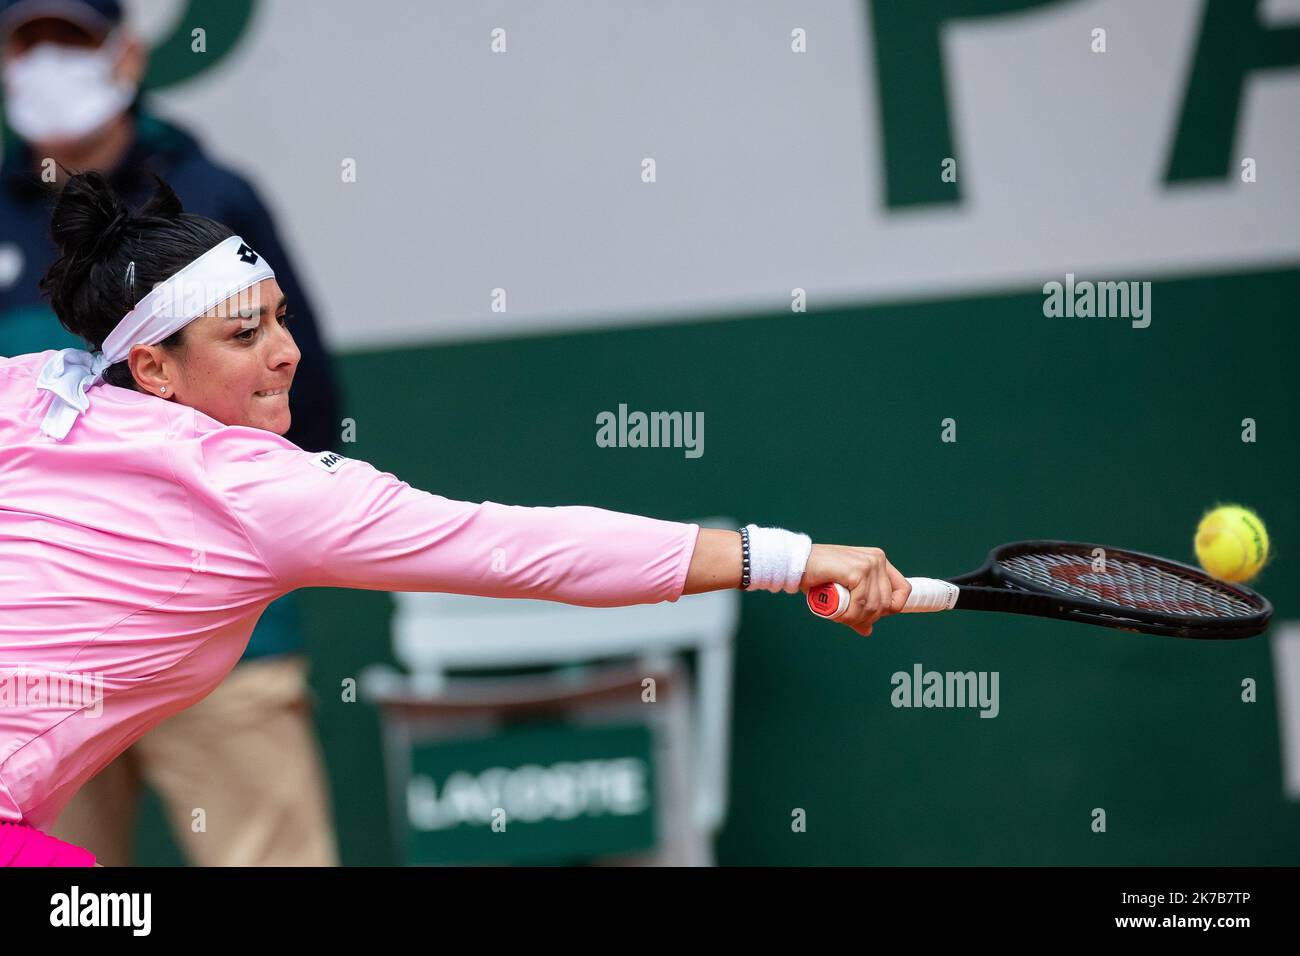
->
<box><xmin>134</xmin><ymin>271</ymin><xmax>1300</xmax><ymax>865</ymax></box>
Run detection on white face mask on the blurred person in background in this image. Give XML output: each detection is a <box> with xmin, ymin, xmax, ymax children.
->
<box><xmin>4</xmin><ymin>35</ymin><xmax>135</xmax><ymax>143</ymax></box>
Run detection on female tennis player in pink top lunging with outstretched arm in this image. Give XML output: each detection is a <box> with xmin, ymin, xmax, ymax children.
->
<box><xmin>0</xmin><ymin>173</ymin><xmax>910</xmax><ymax>865</ymax></box>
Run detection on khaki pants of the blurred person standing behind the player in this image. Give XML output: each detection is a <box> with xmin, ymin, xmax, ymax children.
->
<box><xmin>49</xmin><ymin>654</ymin><xmax>338</xmax><ymax>866</ymax></box>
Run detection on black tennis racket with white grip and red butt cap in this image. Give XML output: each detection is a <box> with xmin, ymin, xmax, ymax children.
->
<box><xmin>807</xmin><ymin>541</ymin><xmax>1273</xmax><ymax>640</ymax></box>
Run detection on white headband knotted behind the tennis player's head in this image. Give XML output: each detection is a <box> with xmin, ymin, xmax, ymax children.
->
<box><xmin>36</xmin><ymin>235</ymin><xmax>276</xmax><ymax>441</ymax></box>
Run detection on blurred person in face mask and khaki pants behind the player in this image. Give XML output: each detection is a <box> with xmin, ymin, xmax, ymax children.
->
<box><xmin>0</xmin><ymin>0</ymin><xmax>338</xmax><ymax>866</ymax></box>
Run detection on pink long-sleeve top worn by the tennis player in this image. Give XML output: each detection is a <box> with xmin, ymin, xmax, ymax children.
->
<box><xmin>0</xmin><ymin>351</ymin><xmax>698</xmax><ymax>827</ymax></box>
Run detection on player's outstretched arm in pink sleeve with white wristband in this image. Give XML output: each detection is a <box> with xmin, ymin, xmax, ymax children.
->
<box><xmin>204</xmin><ymin>428</ymin><xmax>910</xmax><ymax>635</ymax></box>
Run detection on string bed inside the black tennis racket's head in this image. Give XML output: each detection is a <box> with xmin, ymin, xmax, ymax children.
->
<box><xmin>998</xmin><ymin>551</ymin><xmax>1260</xmax><ymax>618</ymax></box>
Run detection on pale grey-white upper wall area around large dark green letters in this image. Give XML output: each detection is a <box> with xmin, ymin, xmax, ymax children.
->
<box><xmin>96</xmin><ymin>0</ymin><xmax>1300</xmax><ymax>349</ymax></box>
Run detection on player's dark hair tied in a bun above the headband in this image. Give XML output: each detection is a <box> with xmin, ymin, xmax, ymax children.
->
<box><xmin>40</xmin><ymin>170</ymin><xmax>234</xmax><ymax>389</ymax></box>
